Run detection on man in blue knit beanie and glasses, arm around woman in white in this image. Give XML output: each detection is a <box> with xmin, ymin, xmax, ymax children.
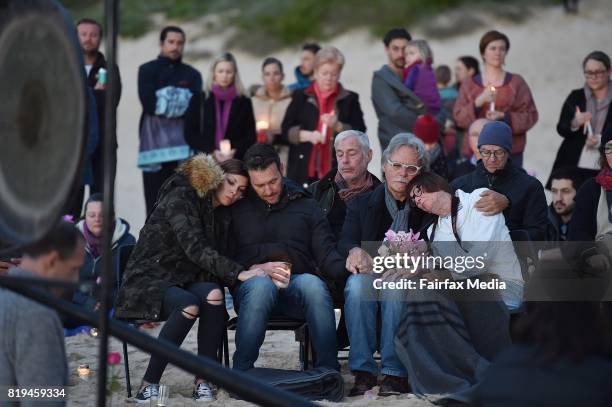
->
<box><xmin>451</xmin><ymin>121</ymin><xmax>548</xmax><ymax>241</ymax></box>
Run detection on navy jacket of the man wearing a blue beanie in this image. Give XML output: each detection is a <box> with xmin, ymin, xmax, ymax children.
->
<box><xmin>451</xmin><ymin>160</ymin><xmax>548</xmax><ymax>241</ymax></box>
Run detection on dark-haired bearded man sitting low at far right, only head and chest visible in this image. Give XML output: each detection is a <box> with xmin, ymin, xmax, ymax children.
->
<box><xmin>548</xmin><ymin>168</ymin><xmax>580</xmax><ymax>241</ymax></box>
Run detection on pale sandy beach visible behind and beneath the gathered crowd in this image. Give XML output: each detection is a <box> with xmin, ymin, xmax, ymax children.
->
<box><xmin>66</xmin><ymin>0</ymin><xmax>612</xmax><ymax>407</ymax></box>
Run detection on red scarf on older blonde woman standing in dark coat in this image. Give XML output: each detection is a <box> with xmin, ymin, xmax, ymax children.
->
<box><xmin>307</xmin><ymin>81</ymin><xmax>340</xmax><ymax>178</ymax></box>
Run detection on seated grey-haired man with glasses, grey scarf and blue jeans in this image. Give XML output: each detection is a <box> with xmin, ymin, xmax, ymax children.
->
<box><xmin>338</xmin><ymin>133</ymin><xmax>430</xmax><ymax>397</ymax></box>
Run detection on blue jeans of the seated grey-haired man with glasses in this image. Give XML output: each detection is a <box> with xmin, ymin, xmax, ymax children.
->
<box><xmin>344</xmin><ymin>274</ymin><xmax>408</xmax><ymax>377</ymax></box>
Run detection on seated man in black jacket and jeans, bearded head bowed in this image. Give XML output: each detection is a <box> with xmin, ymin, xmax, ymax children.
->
<box><xmin>229</xmin><ymin>144</ymin><xmax>345</xmax><ymax>370</ymax></box>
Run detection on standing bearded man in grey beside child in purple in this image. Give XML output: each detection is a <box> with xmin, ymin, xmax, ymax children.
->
<box><xmin>372</xmin><ymin>28</ymin><xmax>426</xmax><ymax>150</ymax></box>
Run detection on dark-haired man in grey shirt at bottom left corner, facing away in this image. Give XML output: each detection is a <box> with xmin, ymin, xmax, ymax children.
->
<box><xmin>0</xmin><ymin>221</ymin><xmax>85</xmax><ymax>394</ymax></box>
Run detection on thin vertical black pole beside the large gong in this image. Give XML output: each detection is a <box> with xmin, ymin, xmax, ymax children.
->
<box><xmin>98</xmin><ymin>0</ymin><xmax>118</xmax><ymax>407</ymax></box>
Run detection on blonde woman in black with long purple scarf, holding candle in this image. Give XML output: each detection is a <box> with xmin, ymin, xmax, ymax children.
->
<box><xmin>185</xmin><ymin>52</ymin><xmax>255</xmax><ymax>162</ymax></box>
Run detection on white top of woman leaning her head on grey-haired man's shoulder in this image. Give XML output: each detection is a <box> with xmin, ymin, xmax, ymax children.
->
<box><xmin>427</xmin><ymin>188</ymin><xmax>524</xmax><ymax>308</ymax></box>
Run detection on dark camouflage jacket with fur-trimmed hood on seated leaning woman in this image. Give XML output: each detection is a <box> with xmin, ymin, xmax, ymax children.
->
<box><xmin>115</xmin><ymin>154</ymin><xmax>243</xmax><ymax>320</ymax></box>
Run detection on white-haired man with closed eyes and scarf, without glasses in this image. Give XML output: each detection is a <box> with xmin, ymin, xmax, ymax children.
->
<box><xmin>308</xmin><ymin>130</ymin><xmax>380</xmax><ymax>239</ymax></box>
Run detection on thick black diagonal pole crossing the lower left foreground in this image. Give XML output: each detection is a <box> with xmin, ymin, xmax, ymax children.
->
<box><xmin>0</xmin><ymin>275</ymin><xmax>318</xmax><ymax>407</ymax></box>
